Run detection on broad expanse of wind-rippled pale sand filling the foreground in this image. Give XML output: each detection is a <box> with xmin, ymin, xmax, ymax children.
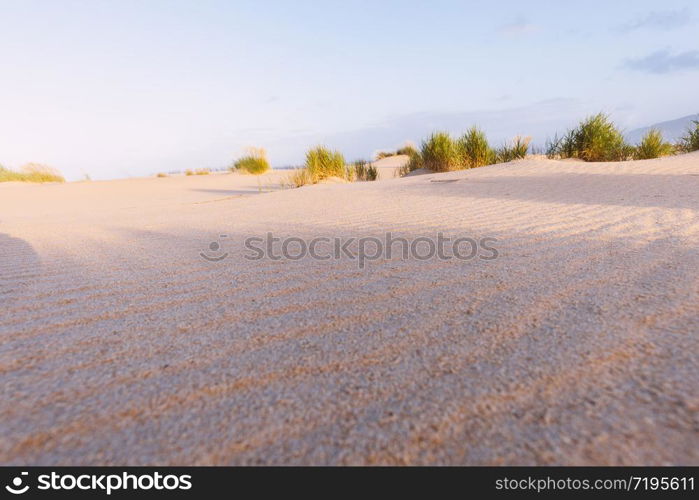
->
<box><xmin>0</xmin><ymin>153</ymin><xmax>699</xmax><ymax>465</ymax></box>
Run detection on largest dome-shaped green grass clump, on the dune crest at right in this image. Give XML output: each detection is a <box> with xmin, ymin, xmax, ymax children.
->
<box><xmin>546</xmin><ymin>113</ymin><xmax>633</xmax><ymax>162</ymax></box>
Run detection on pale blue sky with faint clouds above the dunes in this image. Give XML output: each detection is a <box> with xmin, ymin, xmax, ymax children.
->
<box><xmin>0</xmin><ymin>0</ymin><xmax>699</xmax><ymax>179</ymax></box>
